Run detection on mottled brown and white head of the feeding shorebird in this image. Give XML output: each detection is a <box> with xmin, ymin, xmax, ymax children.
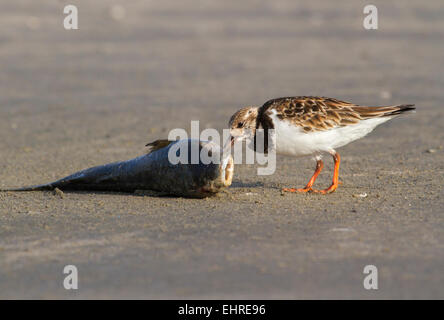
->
<box><xmin>228</xmin><ymin>107</ymin><xmax>259</xmax><ymax>145</ymax></box>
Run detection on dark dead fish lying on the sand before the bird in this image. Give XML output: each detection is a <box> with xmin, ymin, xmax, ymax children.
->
<box><xmin>1</xmin><ymin>139</ymin><xmax>234</xmax><ymax>198</ymax></box>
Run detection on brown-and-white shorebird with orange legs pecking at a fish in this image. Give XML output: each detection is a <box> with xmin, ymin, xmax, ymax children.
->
<box><xmin>228</xmin><ymin>96</ymin><xmax>415</xmax><ymax>194</ymax></box>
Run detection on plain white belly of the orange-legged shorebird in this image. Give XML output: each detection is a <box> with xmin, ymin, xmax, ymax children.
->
<box><xmin>272</xmin><ymin>115</ymin><xmax>390</xmax><ymax>156</ymax></box>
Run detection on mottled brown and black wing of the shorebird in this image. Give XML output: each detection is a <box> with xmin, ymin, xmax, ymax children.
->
<box><xmin>263</xmin><ymin>97</ymin><xmax>414</xmax><ymax>132</ymax></box>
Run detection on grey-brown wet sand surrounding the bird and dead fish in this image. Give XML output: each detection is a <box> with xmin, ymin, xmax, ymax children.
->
<box><xmin>0</xmin><ymin>0</ymin><xmax>444</xmax><ymax>299</ymax></box>
